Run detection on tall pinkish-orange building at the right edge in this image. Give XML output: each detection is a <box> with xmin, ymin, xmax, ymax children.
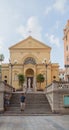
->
<box><xmin>63</xmin><ymin>20</ymin><xmax>69</xmax><ymax>81</ymax></box>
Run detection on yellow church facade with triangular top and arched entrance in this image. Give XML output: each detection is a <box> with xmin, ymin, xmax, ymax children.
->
<box><xmin>2</xmin><ymin>36</ymin><xmax>59</xmax><ymax>91</ymax></box>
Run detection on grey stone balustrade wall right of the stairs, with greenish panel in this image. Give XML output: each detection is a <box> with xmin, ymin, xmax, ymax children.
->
<box><xmin>46</xmin><ymin>81</ymin><xmax>69</xmax><ymax>113</ymax></box>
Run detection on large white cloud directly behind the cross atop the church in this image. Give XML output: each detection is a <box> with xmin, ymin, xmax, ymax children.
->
<box><xmin>17</xmin><ymin>16</ymin><xmax>42</xmax><ymax>40</ymax></box>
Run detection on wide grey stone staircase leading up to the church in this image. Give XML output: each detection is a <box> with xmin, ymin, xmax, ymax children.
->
<box><xmin>4</xmin><ymin>93</ymin><xmax>52</xmax><ymax>115</ymax></box>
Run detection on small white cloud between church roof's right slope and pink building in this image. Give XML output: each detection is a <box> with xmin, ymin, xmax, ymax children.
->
<box><xmin>45</xmin><ymin>33</ymin><xmax>60</xmax><ymax>47</ymax></box>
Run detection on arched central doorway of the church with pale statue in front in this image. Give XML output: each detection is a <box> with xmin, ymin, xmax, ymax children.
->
<box><xmin>26</xmin><ymin>68</ymin><xmax>34</xmax><ymax>90</ymax></box>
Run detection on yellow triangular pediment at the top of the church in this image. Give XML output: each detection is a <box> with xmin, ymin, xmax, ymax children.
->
<box><xmin>9</xmin><ymin>36</ymin><xmax>51</xmax><ymax>49</ymax></box>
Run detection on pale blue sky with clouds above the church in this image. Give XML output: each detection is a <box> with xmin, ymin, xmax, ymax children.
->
<box><xmin>0</xmin><ymin>0</ymin><xmax>69</xmax><ymax>68</ymax></box>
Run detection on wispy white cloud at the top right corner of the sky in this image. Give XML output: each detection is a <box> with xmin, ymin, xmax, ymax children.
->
<box><xmin>45</xmin><ymin>0</ymin><xmax>68</xmax><ymax>15</ymax></box>
